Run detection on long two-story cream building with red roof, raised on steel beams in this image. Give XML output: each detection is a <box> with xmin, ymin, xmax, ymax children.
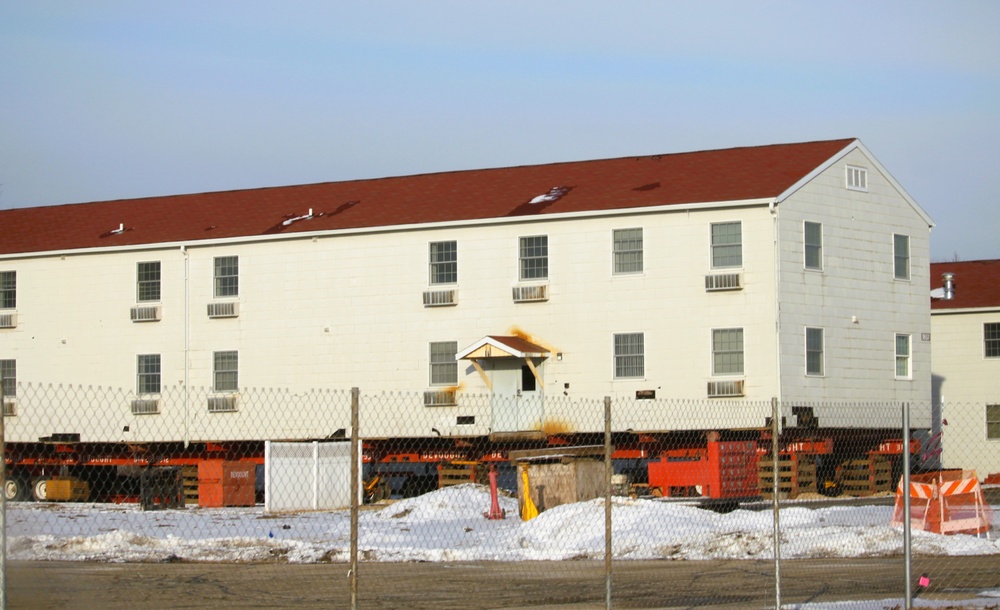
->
<box><xmin>0</xmin><ymin>139</ymin><xmax>932</xmax><ymax>441</ymax></box>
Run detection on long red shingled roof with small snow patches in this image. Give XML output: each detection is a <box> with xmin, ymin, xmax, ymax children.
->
<box><xmin>0</xmin><ymin>139</ymin><xmax>854</xmax><ymax>254</ymax></box>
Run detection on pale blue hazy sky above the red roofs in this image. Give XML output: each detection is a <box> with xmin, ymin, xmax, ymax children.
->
<box><xmin>0</xmin><ymin>0</ymin><xmax>1000</xmax><ymax>261</ymax></box>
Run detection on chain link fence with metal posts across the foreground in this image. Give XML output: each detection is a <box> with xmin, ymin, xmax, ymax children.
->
<box><xmin>3</xmin><ymin>383</ymin><xmax>1000</xmax><ymax>608</ymax></box>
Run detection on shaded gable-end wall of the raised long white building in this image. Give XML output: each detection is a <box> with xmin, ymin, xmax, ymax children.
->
<box><xmin>778</xmin><ymin>150</ymin><xmax>931</xmax><ymax>427</ymax></box>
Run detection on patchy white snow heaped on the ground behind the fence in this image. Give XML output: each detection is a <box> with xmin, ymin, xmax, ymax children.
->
<box><xmin>1</xmin><ymin>484</ymin><xmax>1000</xmax><ymax>609</ymax></box>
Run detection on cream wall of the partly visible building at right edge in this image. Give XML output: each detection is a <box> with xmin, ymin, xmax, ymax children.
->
<box><xmin>931</xmin><ymin>309</ymin><xmax>1000</xmax><ymax>478</ymax></box>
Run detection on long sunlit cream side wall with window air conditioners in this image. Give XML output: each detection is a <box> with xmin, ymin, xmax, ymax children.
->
<box><xmin>0</xmin><ymin>206</ymin><xmax>778</xmax><ymax>440</ymax></box>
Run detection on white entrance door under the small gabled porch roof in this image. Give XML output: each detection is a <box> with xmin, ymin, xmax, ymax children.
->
<box><xmin>492</xmin><ymin>358</ymin><xmax>543</xmax><ymax>432</ymax></box>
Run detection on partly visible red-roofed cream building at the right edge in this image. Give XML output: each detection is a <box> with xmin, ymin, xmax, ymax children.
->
<box><xmin>925</xmin><ymin>260</ymin><xmax>1000</xmax><ymax>479</ymax></box>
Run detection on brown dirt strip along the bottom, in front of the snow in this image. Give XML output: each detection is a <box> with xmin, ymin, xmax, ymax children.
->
<box><xmin>7</xmin><ymin>556</ymin><xmax>1000</xmax><ymax>610</ymax></box>
